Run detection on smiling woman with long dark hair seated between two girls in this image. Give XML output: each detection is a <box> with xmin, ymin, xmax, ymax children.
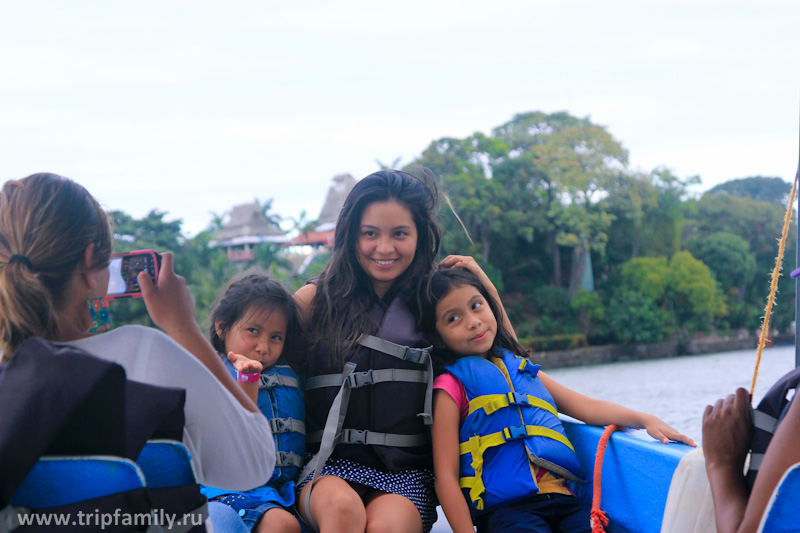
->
<box><xmin>295</xmin><ymin>170</ymin><xmax>441</xmax><ymax>533</ymax></box>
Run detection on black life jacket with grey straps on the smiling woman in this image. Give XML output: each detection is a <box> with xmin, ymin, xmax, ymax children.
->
<box><xmin>305</xmin><ymin>292</ymin><xmax>433</xmax><ymax>471</ymax></box>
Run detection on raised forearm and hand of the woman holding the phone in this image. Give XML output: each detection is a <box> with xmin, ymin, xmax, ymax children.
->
<box><xmin>137</xmin><ymin>252</ymin><xmax>259</xmax><ymax>413</ymax></box>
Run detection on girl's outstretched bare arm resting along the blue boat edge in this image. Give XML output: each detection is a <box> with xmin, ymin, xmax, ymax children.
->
<box><xmin>538</xmin><ymin>371</ymin><xmax>696</xmax><ymax>446</ymax></box>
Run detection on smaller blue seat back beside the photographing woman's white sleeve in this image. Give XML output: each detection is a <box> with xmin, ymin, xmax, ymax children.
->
<box><xmin>136</xmin><ymin>440</ymin><xmax>197</xmax><ymax>489</ymax></box>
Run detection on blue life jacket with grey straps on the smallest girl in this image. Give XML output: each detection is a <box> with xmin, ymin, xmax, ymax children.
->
<box><xmin>203</xmin><ymin>356</ymin><xmax>306</xmax><ymax>507</ymax></box>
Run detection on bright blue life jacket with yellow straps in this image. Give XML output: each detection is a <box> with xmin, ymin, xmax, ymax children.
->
<box><xmin>445</xmin><ymin>349</ymin><xmax>580</xmax><ymax>516</ymax></box>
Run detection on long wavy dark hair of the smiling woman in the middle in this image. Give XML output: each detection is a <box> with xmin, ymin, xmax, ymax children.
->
<box><xmin>308</xmin><ymin>169</ymin><xmax>442</xmax><ymax>367</ymax></box>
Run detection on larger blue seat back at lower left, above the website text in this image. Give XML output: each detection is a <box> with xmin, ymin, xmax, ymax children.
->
<box><xmin>10</xmin><ymin>455</ymin><xmax>145</xmax><ymax>509</ymax></box>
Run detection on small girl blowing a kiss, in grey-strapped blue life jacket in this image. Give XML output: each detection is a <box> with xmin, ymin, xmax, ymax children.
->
<box><xmin>203</xmin><ymin>273</ymin><xmax>305</xmax><ymax>533</ymax></box>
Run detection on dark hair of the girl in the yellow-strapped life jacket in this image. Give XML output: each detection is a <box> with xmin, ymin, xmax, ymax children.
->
<box><xmin>420</xmin><ymin>268</ymin><xmax>527</xmax><ymax>374</ymax></box>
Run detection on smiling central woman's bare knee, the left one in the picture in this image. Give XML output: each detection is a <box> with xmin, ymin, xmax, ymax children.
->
<box><xmin>298</xmin><ymin>476</ymin><xmax>366</xmax><ymax>533</ymax></box>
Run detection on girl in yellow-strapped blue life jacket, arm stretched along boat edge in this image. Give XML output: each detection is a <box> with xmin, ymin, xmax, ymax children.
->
<box><xmin>422</xmin><ymin>262</ymin><xmax>694</xmax><ymax>533</ymax></box>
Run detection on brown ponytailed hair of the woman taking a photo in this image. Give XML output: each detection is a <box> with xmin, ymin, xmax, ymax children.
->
<box><xmin>0</xmin><ymin>173</ymin><xmax>111</xmax><ymax>360</ymax></box>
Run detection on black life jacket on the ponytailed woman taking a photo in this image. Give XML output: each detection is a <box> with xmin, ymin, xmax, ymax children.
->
<box><xmin>0</xmin><ymin>338</ymin><xmax>205</xmax><ymax>532</ymax></box>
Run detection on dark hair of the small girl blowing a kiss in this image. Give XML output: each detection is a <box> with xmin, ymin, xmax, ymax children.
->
<box><xmin>208</xmin><ymin>272</ymin><xmax>302</xmax><ymax>366</ymax></box>
